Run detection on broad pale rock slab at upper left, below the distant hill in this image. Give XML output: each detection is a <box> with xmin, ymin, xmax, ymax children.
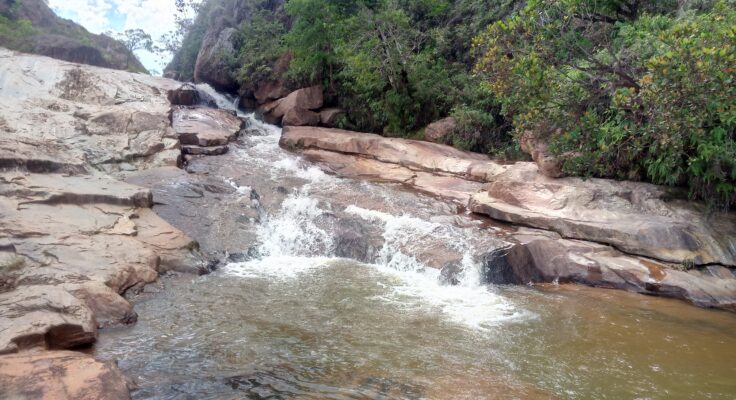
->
<box><xmin>0</xmin><ymin>50</ymin><xmax>180</xmax><ymax>174</ymax></box>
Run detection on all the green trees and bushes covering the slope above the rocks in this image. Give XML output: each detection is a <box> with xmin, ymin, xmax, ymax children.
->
<box><xmin>177</xmin><ymin>0</ymin><xmax>736</xmax><ymax>208</ymax></box>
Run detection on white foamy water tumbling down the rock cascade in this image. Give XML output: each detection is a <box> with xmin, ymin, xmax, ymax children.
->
<box><xmin>197</xmin><ymin>85</ymin><xmax>529</xmax><ymax>329</ymax></box>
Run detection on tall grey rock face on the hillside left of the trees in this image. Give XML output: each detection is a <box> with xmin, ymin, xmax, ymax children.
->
<box><xmin>194</xmin><ymin>28</ymin><xmax>237</xmax><ymax>92</ymax></box>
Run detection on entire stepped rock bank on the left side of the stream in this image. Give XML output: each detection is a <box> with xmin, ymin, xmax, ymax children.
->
<box><xmin>0</xmin><ymin>48</ymin><xmax>244</xmax><ymax>399</ymax></box>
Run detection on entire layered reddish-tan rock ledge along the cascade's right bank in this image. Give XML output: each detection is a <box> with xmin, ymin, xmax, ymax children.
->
<box><xmin>280</xmin><ymin>127</ymin><xmax>736</xmax><ymax>311</ymax></box>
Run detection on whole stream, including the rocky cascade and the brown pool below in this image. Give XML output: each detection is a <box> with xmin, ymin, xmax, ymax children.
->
<box><xmin>93</xmin><ymin>88</ymin><xmax>736</xmax><ymax>399</ymax></box>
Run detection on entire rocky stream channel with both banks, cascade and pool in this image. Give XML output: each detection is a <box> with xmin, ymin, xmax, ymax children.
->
<box><xmin>0</xmin><ymin>50</ymin><xmax>736</xmax><ymax>399</ymax></box>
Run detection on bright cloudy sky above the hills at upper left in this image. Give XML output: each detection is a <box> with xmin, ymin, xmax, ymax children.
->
<box><xmin>49</xmin><ymin>0</ymin><xmax>194</xmax><ymax>72</ymax></box>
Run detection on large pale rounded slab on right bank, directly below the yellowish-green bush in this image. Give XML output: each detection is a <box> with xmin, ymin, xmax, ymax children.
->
<box><xmin>469</xmin><ymin>164</ymin><xmax>736</xmax><ymax>266</ymax></box>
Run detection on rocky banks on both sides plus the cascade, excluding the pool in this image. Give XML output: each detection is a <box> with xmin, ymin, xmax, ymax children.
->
<box><xmin>0</xmin><ymin>49</ymin><xmax>736</xmax><ymax>398</ymax></box>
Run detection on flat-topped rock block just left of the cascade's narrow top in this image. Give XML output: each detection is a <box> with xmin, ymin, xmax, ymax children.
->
<box><xmin>172</xmin><ymin>107</ymin><xmax>244</xmax><ymax>147</ymax></box>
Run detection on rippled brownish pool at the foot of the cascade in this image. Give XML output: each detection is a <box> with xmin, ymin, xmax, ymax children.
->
<box><xmin>96</xmin><ymin>258</ymin><xmax>736</xmax><ymax>399</ymax></box>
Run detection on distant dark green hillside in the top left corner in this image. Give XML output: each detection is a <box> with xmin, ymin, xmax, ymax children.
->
<box><xmin>0</xmin><ymin>0</ymin><xmax>147</xmax><ymax>72</ymax></box>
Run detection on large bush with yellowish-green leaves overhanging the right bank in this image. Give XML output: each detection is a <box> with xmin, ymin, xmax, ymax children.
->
<box><xmin>474</xmin><ymin>0</ymin><xmax>736</xmax><ymax>207</ymax></box>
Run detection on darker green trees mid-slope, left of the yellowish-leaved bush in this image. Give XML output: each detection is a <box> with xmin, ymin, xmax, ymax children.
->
<box><xmin>223</xmin><ymin>0</ymin><xmax>515</xmax><ymax>151</ymax></box>
